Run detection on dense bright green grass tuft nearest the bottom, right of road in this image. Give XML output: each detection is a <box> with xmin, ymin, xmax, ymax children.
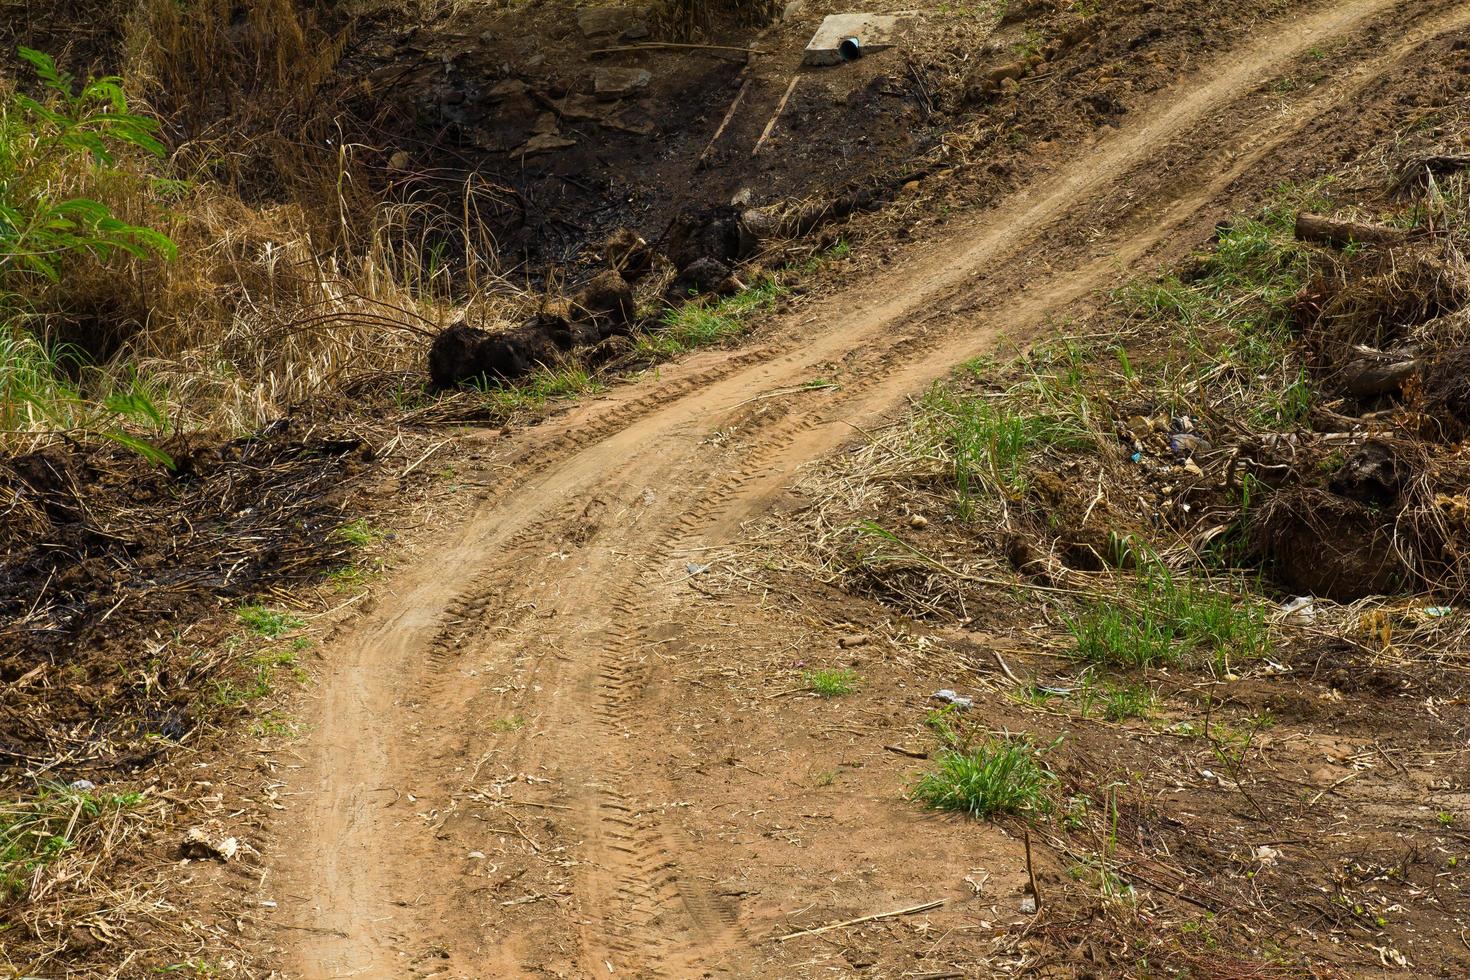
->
<box><xmin>910</xmin><ymin>739</ymin><xmax>1057</xmax><ymax>820</ymax></box>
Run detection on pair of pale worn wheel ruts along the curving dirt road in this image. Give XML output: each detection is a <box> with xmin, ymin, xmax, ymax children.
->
<box><xmin>267</xmin><ymin>0</ymin><xmax>1470</xmax><ymax>979</ymax></box>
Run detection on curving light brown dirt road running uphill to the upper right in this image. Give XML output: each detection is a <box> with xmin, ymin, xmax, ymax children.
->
<box><xmin>262</xmin><ymin>0</ymin><xmax>1470</xmax><ymax>980</ymax></box>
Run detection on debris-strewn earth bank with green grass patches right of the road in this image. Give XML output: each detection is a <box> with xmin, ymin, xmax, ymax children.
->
<box><xmin>770</xmin><ymin>22</ymin><xmax>1470</xmax><ymax>977</ymax></box>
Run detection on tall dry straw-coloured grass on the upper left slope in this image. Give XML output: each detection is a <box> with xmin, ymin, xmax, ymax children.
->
<box><xmin>0</xmin><ymin>0</ymin><xmax>543</xmax><ymax>445</ymax></box>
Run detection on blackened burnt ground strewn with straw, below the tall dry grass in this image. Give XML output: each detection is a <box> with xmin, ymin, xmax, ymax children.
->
<box><xmin>0</xmin><ymin>420</ymin><xmax>385</xmax><ymax>773</ymax></box>
